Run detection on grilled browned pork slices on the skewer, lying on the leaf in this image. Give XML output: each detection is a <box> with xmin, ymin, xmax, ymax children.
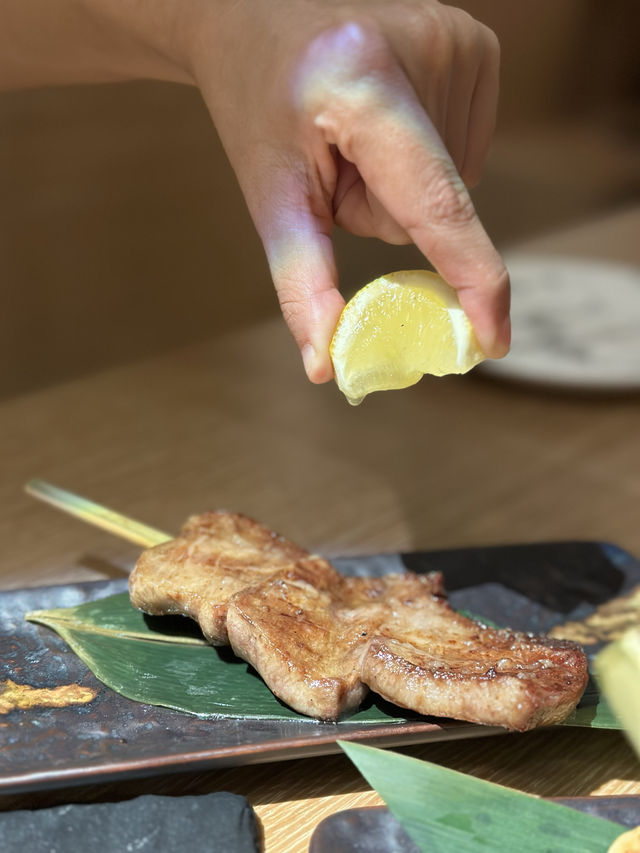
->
<box><xmin>130</xmin><ymin>512</ymin><xmax>587</xmax><ymax>731</ymax></box>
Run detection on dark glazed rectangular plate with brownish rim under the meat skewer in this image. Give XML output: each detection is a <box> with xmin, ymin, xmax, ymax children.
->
<box><xmin>0</xmin><ymin>542</ymin><xmax>640</xmax><ymax>793</ymax></box>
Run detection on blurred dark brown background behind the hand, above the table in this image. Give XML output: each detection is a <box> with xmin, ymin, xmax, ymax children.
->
<box><xmin>0</xmin><ymin>0</ymin><xmax>640</xmax><ymax>396</ymax></box>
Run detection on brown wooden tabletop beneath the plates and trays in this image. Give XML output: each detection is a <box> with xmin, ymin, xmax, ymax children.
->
<box><xmin>0</xmin><ymin>209</ymin><xmax>640</xmax><ymax>853</ymax></box>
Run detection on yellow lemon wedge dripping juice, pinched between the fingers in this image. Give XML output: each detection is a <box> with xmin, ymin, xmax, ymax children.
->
<box><xmin>329</xmin><ymin>270</ymin><xmax>485</xmax><ymax>406</ymax></box>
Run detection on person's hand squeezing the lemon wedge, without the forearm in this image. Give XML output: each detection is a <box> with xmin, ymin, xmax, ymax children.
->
<box><xmin>192</xmin><ymin>0</ymin><xmax>509</xmax><ymax>382</ymax></box>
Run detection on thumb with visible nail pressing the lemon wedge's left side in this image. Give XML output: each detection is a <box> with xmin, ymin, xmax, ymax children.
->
<box><xmin>254</xmin><ymin>192</ymin><xmax>344</xmax><ymax>383</ymax></box>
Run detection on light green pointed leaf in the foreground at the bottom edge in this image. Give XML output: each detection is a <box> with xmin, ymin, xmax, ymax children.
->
<box><xmin>338</xmin><ymin>741</ymin><xmax>626</xmax><ymax>853</ymax></box>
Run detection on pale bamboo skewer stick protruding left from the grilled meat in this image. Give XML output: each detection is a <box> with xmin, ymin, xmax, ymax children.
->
<box><xmin>25</xmin><ymin>479</ymin><xmax>174</xmax><ymax>548</ymax></box>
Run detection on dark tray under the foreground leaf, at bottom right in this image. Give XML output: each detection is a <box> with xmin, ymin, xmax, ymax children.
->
<box><xmin>309</xmin><ymin>797</ymin><xmax>640</xmax><ymax>853</ymax></box>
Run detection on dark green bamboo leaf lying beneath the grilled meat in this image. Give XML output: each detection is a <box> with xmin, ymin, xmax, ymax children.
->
<box><xmin>25</xmin><ymin>593</ymin><xmax>406</xmax><ymax>724</ymax></box>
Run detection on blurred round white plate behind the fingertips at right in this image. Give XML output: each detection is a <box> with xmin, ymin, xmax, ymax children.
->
<box><xmin>480</xmin><ymin>251</ymin><xmax>640</xmax><ymax>391</ymax></box>
